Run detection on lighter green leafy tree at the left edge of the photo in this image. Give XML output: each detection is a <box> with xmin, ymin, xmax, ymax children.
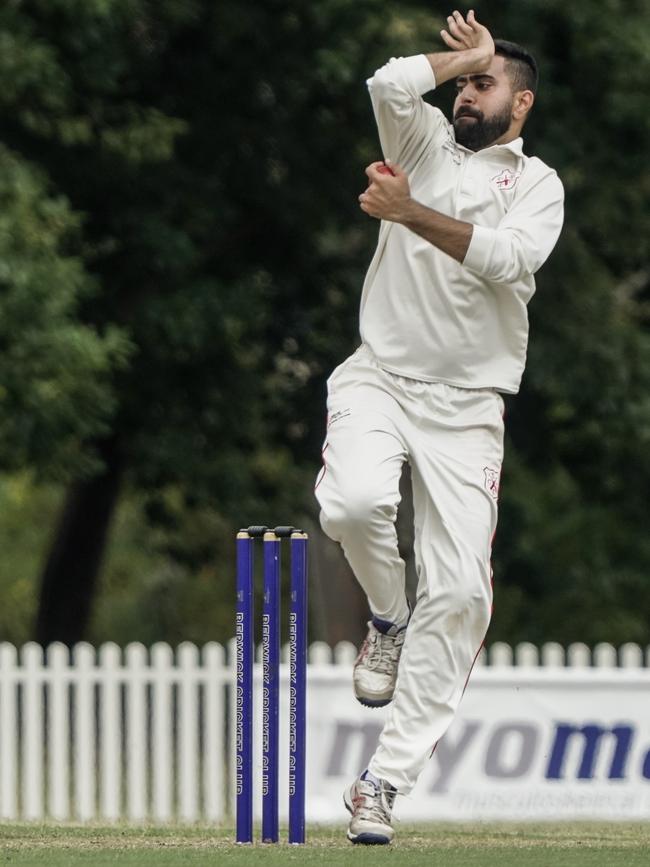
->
<box><xmin>0</xmin><ymin>146</ymin><xmax>128</xmax><ymax>479</ymax></box>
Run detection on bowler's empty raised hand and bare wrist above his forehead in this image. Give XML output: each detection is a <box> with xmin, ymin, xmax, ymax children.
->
<box><xmin>427</xmin><ymin>9</ymin><xmax>494</xmax><ymax>86</ymax></box>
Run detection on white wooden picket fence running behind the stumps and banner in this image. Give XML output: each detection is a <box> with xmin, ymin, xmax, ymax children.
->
<box><xmin>0</xmin><ymin>642</ymin><xmax>650</xmax><ymax>822</ymax></box>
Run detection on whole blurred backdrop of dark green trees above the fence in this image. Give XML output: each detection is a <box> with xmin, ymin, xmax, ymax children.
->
<box><xmin>0</xmin><ymin>0</ymin><xmax>650</xmax><ymax>668</ymax></box>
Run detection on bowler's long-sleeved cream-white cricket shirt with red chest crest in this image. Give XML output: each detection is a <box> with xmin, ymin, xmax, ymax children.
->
<box><xmin>360</xmin><ymin>55</ymin><xmax>564</xmax><ymax>393</ymax></box>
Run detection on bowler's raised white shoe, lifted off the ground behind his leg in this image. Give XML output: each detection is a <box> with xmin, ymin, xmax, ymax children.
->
<box><xmin>352</xmin><ymin>620</ymin><xmax>406</xmax><ymax>707</ymax></box>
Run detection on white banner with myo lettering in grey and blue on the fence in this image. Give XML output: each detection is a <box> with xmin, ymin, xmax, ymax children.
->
<box><xmin>308</xmin><ymin>669</ymin><xmax>650</xmax><ymax>821</ymax></box>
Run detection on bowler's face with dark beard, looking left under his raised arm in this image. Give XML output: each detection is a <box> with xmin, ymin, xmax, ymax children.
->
<box><xmin>454</xmin><ymin>55</ymin><xmax>518</xmax><ymax>151</ymax></box>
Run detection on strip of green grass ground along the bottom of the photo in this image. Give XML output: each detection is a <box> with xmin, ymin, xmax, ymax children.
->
<box><xmin>0</xmin><ymin>822</ymin><xmax>650</xmax><ymax>867</ymax></box>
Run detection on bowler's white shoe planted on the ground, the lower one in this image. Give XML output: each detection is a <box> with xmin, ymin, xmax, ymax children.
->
<box><xmin>343</xmin><ymin>771</ymin><xmax>397</xmax><ymax>846</ymax></box>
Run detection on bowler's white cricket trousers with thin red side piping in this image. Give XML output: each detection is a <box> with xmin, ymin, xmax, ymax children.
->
<box><xmin>316</xmin><ymin>345</ymin><xmax>503</xmax><ymax>794</ymax></box>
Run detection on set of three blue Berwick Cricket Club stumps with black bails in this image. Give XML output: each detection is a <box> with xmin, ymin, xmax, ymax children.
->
<box><xmin>236</xmin><ymin>526</ymin><xmax>309</xmax><ymax>843</ymax></box>
